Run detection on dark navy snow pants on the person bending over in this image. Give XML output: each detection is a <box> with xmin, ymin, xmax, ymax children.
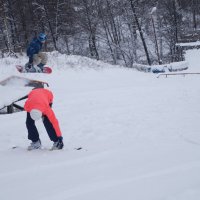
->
<box><xmin>26</xmin><ymin>112</ymin><xmax>58</xmax><ymax>142</ymax></box>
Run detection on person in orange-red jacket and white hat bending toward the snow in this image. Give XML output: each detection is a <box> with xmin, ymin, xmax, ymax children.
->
<box><xmin>24</xmin><ymin>88</ymin><xmax>64</xmax><ymax>150</ymax></box>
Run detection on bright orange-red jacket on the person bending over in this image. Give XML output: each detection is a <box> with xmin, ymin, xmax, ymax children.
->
<box><xmin>24</xmin><ymin>88</ymin><xmax>62</xmax><ymax>137</ymax></box>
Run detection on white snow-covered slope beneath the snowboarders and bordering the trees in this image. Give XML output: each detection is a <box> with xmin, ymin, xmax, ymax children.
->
<box><xmin>0</xmin><ymin>51</ymin><xmax>200</xmax><ymax>200</ymax></box>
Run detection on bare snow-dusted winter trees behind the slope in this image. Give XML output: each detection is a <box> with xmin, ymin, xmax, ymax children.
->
<box><xmin>0</xmin><ymin>0</ymin><xmax>200</xmax><ymax>67</ymax></box>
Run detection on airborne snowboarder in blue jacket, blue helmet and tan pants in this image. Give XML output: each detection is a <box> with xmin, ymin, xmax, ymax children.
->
<box><xmin>25</xmin><ymin>33</ymin><xmax>47</xmax><ymax>72</ymax></box>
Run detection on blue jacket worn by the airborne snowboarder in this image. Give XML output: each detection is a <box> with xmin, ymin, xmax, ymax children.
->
<box><xmin>26</xmin><ymin>38</ymin><xmax>42</xmax><ymax>63</ymax></box>
